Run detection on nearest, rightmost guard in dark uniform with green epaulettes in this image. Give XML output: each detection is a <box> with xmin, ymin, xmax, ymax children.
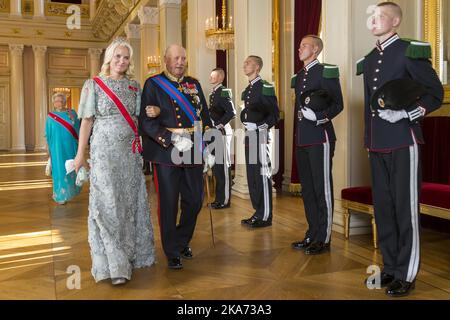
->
<box><xmin>357</xmin><ymin>2</ymin><xmax>443</xmax><ymax>297</ymax></box>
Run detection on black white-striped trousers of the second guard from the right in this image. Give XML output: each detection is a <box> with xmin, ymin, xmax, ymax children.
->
<box><xmin>296</xmin><ymin>142</ymin><xmax>336</xmax><ymax>243</ymax></box>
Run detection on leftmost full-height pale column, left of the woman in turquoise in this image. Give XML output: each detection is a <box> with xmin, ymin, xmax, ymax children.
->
<box><xmin>9</xmin><ymin>44</ymin><xmax>25</xmax><ymax>150</ymax></box>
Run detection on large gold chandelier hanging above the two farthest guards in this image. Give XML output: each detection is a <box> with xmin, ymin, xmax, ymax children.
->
<box><xmin>205</xmin><ymin>0</ymin><xmax>234</xmax><ymax>50</ymax></box>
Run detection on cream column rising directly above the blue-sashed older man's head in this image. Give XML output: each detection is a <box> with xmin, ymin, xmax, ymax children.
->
<box><xmin>159</xmin><ymin>0</ymin><xmax>182</xmax><ymax>57</ymax></box>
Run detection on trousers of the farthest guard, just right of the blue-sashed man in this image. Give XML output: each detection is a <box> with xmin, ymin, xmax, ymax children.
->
<box><xmin>212</xmin><ymin>135</ymin><xmax>232</xmax><ymax>205</ymax></box>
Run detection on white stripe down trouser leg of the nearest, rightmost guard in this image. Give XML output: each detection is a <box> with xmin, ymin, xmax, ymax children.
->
<box><xmin>406</xmin><ymin>144</ymin><xmax>420</xmax><ymax>282</ymax></box>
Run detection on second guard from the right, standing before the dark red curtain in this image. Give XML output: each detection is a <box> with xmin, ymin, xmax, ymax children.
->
<box><xmin>291</xmin><ymin>35</ymin><xmax>343</xmax><ymax>255</ymax></box>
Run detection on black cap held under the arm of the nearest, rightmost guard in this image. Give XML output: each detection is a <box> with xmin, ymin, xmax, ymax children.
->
<box><xmin>371</xmin><ymin>78</ymin><xmax>426</xmax><ymax>110</ymax></box>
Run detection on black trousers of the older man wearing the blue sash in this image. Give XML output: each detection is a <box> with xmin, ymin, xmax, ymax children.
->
<box><xmin>154</xmin><ymin>164</ymin><xmax>203</xmax><ymax>259</ymax></box>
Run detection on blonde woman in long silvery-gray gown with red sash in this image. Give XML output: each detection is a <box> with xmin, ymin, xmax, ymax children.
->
<box><xmin>75</xmin><ymin>38</ymin><xmax>155</xmax><ymax>285</ymax></box>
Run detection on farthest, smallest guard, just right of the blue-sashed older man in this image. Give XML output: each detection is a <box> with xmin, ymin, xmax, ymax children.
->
<box><xmin>209</xmin><ymin>68</ymin><xmax>236</xmax><ymax>209</ymax></box>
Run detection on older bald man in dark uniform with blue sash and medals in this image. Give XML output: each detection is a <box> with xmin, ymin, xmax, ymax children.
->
<box><xmin>139</xmin><ymin>45</ymin><xmax>212</xmax><ymax>269</ymax></box>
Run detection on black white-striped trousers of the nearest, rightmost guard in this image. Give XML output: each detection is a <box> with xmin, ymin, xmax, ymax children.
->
<box><xmin>370</xmin><ymin>145</ymin><xmax>422</xmax><ymax>282</ymax></box>
